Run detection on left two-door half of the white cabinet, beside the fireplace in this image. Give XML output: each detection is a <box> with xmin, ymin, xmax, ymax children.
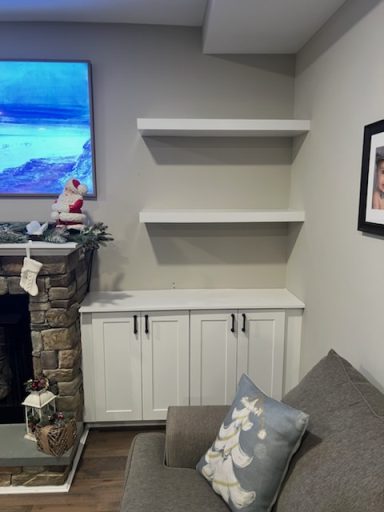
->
<box><xmin>82</xmin><ymin>311</ymin><xmax>189</xmax><ymax>421</ymax></box>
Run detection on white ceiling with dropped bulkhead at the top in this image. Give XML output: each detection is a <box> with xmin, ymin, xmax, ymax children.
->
<box><xmin>0</xmin><ymin>0</ymin><xmax>346</xmax><ymax>53</ymax></box>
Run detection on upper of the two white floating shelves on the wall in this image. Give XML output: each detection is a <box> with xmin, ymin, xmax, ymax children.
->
<box><xmin>137</xmin><ymin>118</ymin><xmax>311</xmax><ymax>137</ymax></box>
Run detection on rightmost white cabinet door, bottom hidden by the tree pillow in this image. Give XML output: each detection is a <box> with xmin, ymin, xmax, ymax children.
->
<box><xmin>237</xmin><ymin>310</ymin><xmax>285</xmax><ymax>399</ymax></box>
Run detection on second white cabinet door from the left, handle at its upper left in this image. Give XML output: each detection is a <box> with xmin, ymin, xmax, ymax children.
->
<box><xmin>140</xmin><ymin>311</ymin><xmax>189</xmax><ymax>420</ymax></box>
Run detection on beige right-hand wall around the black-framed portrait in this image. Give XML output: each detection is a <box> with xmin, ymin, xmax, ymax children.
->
<box><xmin>287</xmin><ymin>0</ymin><xmax>384</xmax><ymax>388</ymax></box>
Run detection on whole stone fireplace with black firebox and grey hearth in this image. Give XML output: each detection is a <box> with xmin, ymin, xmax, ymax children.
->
<box><xmin>0</xmin><ymin>243</ymin><xmax>92</xmax><ymax>487</ymax></box>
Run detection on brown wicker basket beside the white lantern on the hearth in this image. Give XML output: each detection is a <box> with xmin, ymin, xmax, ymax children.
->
<box><xmin>35</xmin><ymin>419</ymin><xmax>77</xmax><ymax>457</ymax></box>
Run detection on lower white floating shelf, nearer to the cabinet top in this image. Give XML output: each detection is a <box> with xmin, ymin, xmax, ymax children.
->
<box><xmin>140</xmin><ymin>210</ymin><xmax>305</xmax><ymax>224</ymax></box>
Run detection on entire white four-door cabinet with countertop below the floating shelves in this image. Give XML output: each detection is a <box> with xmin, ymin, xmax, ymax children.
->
<box><xmin>80</xmin><ymin>289</ymin><xmax>304</xmax><ymax>423</ymax></box>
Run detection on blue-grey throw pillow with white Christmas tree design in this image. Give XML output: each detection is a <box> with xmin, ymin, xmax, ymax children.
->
<box><xmin>196</xmin><ymin>375</ymin><xmax>309</xmax><ymax>512</ymax></box>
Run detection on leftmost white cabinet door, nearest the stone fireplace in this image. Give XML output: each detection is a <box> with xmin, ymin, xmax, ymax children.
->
<box><xmin>92</xmin><ymin>313</ymin><xmax>142</xmax><ymax>421</ymax></box>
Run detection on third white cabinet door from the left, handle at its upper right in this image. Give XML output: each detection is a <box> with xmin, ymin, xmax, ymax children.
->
<box><xmin>191</xmin><ymin>311</ymin><xmax>237</xmax><ymax>405</ymax></box>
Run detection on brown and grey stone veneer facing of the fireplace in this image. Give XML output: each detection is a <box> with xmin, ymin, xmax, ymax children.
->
<box><xmin>0</xmin><ymin>249</ymin><xmax>92</xmax><ymax>486</ymax></box>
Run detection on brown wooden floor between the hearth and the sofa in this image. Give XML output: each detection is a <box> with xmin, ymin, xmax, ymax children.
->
<box><xmin>0</xmin><ymin>429</ymin><xmax>159</xmax><ymax>512</ymax></box>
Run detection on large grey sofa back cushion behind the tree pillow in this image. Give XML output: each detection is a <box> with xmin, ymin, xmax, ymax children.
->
<box><xmin>275</xmin><ymin>350</ymin><xmax>384</xmax><ymax>512</ymax></box>
